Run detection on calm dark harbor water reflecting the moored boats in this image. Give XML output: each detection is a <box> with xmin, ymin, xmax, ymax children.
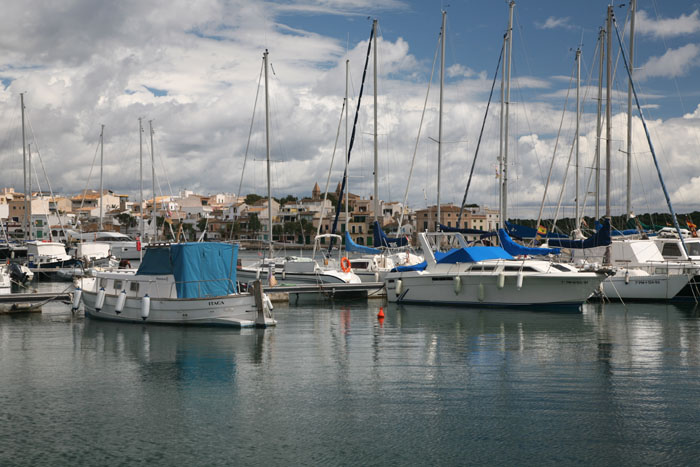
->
<box><xmin>0</xmin><ymin>284</ymin><xmax>700</xmax><ymax>466</ymax></box>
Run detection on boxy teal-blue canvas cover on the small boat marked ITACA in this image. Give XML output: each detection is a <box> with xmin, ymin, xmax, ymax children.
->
<box><xmin>136</xmin><ymin>242</ymin><xmax>238</xmax><ymax>298</ymax></box>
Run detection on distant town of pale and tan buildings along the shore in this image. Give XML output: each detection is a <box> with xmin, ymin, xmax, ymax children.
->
<box><xmin>0</xmin><ymin>184</ymin><xmax>499</xmax><ymax>246</ymax></box>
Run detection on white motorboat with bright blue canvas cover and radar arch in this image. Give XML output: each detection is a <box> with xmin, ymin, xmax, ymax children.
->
<box><xmin>385</xmin><ymin>232</ymin><xmax>606</xmax><ymax>309</ymax></box>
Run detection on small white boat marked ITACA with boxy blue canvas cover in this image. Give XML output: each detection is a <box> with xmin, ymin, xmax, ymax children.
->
<box><xmin>73</xmin><ymin>243</ymin><xmax>276</xmax><ymax>327</ymax></box>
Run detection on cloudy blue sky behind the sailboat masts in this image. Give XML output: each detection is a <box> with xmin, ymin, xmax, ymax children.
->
<box><xmin>0</xmin><ymin>0</ymin><xmax>700</xmax><ymax>217</ymax></box>
